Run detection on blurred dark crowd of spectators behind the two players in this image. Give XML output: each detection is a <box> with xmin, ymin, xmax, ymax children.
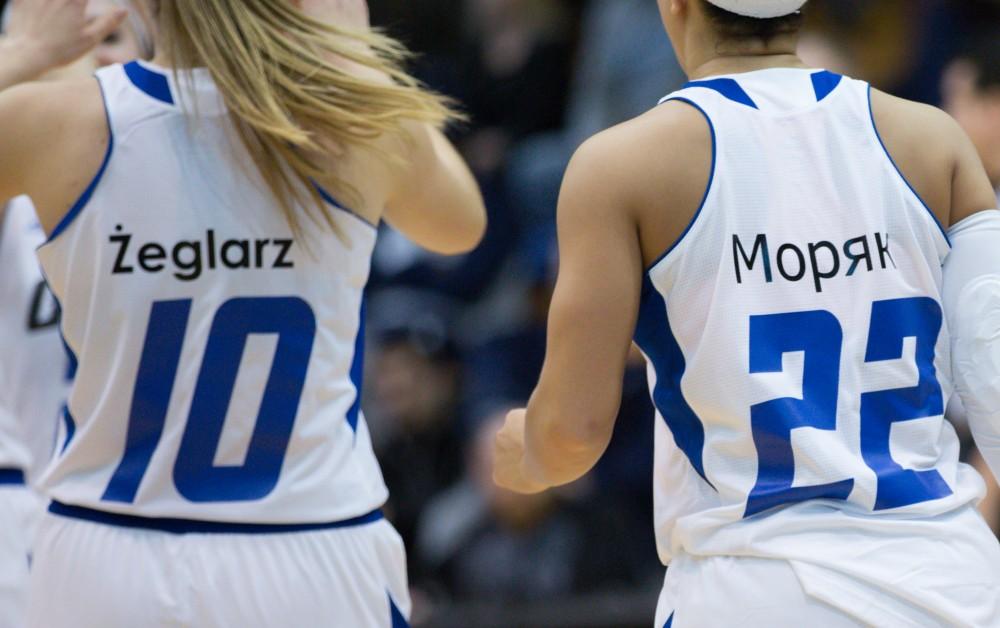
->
<box><xmin>364</xmin><ymin>0</ymin><xmax>1000</xmax><ymax>628</ymax></box>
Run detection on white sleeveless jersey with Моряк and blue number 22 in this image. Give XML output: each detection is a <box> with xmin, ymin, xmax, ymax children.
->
<box><xmin>636</xmin><ymin>69</ymin><xmax>1000</xmax><ymax>625</ymax></box>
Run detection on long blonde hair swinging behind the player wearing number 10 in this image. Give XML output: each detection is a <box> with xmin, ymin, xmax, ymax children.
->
<box><xmin>153</xmin><ymin>0</ymin><xmax>459</xmax><ymax>232</ymax></box>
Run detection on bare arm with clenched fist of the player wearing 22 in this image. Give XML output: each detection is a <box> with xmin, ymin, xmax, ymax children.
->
<box><xmin>496</xmin><ymin>103</ymin><xmax>711</xmax><ymax>492</ymax></box>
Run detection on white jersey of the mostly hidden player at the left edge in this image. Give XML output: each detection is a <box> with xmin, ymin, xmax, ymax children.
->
<box><xmin>0</xmin><ymin>197</ymin><xmax>67</xmax><ymax>478</ymax></box>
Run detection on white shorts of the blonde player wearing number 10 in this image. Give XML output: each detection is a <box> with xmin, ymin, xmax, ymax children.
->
<box><xmin>28</xmin><ymin>514</ymin><xmax>410</xmax><ymax>628</ymax></box>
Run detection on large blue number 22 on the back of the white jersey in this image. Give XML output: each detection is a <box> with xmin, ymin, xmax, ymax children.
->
<box><xmin>745</xmin><ymin>298</ymin><xmax>951</xmax><ymax>517</ymax></box>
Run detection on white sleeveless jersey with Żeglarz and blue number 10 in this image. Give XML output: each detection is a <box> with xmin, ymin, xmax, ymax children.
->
<box><xmin>39</xmin><ymin>63</ymin><xmax>387</xmax><ymax>524</ymax></box>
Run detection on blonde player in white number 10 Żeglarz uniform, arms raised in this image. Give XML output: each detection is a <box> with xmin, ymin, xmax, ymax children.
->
<box><xmin>0</xmin><ymin>0</ymin><xmax>485</xmax><ymax>628</ymax></box>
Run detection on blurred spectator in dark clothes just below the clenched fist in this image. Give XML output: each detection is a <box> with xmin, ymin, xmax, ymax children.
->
<box><xmin>414</xmin><ymin>412</ymin><xmax>649</xmax><ymax>601</ymax></box>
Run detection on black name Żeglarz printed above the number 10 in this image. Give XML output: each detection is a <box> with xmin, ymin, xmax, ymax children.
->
<box><xmin>108</xmin><ymin>225</ymin><xmax>295</xmax><ymax>281</ymax></box>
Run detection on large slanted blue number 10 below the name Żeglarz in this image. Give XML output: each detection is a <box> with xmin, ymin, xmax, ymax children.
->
<box><xmin>102</xmin><ymin>297</ymin><xmax>316</xmax><ymax>503</ymax></box>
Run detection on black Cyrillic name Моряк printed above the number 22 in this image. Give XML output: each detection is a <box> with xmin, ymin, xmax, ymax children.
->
<box><xmin>733</xmin><ymin>233</ymin><xmax>896</xmax><ymax>292</ymax></box>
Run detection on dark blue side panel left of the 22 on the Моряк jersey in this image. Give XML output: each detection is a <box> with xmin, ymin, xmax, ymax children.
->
<box><xmin>635</xmin><ymin>276</ymin><xmax>715</xmax><ymax>488</ymax></box>
